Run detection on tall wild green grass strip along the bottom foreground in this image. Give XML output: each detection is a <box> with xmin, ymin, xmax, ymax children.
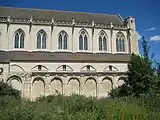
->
<box><xmin>0</xmin><ymin>95</ymin><xmax>160</xmax><ymax>120</ymax></box>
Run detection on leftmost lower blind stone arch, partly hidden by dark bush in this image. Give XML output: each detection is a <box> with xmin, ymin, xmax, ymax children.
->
<box><xmin>7</xmin><ymin>75</ymin><xmax>23</xmax><ymax>92</ymax></box>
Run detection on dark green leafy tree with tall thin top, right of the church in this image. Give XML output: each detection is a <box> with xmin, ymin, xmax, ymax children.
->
<box><xmin>110</xmin><ymin>37</ymin><xmax>155</xmax><ymax>97</ymax></box>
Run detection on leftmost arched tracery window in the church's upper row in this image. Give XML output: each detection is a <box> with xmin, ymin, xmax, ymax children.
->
<box><xmin>14</xmin><ymin>29</ymin><xmax>24</xmax><ymax>48</ymax></box>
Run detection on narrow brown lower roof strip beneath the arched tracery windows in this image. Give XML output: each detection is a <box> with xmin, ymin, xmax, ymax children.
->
<box><xmin>0</xmin><ymin>51</ymin><xmax>130</xmax><ymax>62</ymax></box>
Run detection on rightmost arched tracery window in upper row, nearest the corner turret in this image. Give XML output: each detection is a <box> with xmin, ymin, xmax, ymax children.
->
<box><xmin>116</xmin><ymin>32</ymin><xmax>125</xmax><ymax>52</ymax></box>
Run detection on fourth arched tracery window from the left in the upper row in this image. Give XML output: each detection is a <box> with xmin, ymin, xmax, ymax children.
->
<box><xmin>79</xmin><ymin>30</ymin><xmax>88</xmax><ymax>50</ymax></box>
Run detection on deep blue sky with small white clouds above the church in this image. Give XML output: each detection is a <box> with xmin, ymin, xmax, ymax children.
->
<box><xmin>0</xmin><ymin>0</ymin><xmax>160</xmax><ymax>61</ymax></box>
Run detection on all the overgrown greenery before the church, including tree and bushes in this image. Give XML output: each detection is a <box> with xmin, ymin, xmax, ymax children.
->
<box><xmin>0</xmin><ymin>37</ymin><xmax>160</xmax><ymax>120</ymax></box>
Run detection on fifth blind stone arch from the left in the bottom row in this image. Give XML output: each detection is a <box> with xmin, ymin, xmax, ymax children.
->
<box><xmin>83</xmin><ymin>77</ymin><xmax>97</xmax><ymax>97</ymax></box>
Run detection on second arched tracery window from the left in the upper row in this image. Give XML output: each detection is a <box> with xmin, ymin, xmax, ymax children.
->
<box><xmin>37</xmin><ymin>30</ymin><xmax>47</xmax><ymax>49</ymax></box>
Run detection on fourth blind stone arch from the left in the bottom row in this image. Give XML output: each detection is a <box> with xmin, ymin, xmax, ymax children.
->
<box><xmin>66</xmin><ymin>77</ymin><xmax>80</xmax><ymax>95</ymax></box>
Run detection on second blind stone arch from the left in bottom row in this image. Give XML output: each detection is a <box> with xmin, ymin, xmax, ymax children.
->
<box><xmin>32</xmin><ymin>77</ymin><xmax>45</xmax><ymax>99</ymax></box>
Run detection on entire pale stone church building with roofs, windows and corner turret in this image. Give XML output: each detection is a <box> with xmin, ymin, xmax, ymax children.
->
<box><xmin>0</xmin><ymin>7</ymin><xmax>139</xmax><ymax>100</ymax></box>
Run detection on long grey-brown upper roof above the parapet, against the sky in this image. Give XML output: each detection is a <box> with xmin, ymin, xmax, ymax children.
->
<box><xmin>0</xmin><ymin>7</ymin><xmax>124</xmax><ymax>25</ymax></box>
